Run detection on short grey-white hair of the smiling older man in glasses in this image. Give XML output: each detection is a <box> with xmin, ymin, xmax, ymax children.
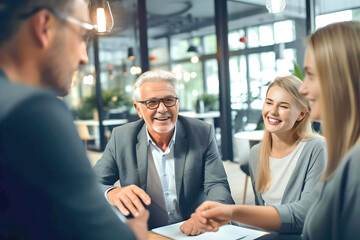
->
<box><xmin>133</xmin><ymin>70</ymin><xmax>179</xmax><ymax>102</ymax></box>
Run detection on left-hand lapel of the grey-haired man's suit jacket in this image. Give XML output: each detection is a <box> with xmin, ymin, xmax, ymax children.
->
<box><xmin>136</xmin><ymin>123</ymin><xmax>148</xmax><ymax>191</ymax></box>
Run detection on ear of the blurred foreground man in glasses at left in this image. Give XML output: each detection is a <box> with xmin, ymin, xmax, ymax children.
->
<box><xmin>29</xmin><ymin>9</ymin><xmax>56</xmax><ymax>48</ymax></box>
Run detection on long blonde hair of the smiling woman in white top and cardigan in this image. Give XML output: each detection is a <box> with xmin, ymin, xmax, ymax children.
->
<box><xmin>256</xmin><ymin>75</ymin><xmax>315</xmax><ymax>193</ymax></box>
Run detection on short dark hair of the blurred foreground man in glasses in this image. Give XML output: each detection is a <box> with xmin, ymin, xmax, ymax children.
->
<box><xmin>0</xmin><ymin>0</ymin><xmax>81</xmax><ymax>46</ymax></box>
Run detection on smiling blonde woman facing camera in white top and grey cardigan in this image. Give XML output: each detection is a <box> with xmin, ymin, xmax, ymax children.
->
<box><xmin>192</xmin><ymin>76</ymin><xmax>326</xmax><ymax>234</ymax></box>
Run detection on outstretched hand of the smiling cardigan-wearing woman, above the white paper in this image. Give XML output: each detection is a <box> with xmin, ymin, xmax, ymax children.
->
<box><xmin>190</xmin><ymin>201</ymin><xmax>232</xmax><ymax>232</ymax></box>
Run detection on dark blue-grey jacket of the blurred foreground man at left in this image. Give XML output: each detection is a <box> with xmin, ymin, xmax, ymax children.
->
<box><xmin>0</xmin><ymin>70</ymin><xmax>135</xmax><ymax>240</ymax></box>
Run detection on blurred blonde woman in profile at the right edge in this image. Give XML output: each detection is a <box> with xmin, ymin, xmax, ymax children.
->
<box><xmin>300</xmin><ymin>21</ymin><xmax>360</xmax><ymax>240</ymax></box>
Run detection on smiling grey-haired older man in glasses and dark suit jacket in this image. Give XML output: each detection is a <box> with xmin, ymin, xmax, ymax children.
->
<box><xmin>94</xmin><ymin>71</ymin><xmax>233</xmax><ymax>235</ymax></box>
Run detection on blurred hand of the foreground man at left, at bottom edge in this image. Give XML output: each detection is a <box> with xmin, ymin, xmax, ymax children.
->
<box><xmin>126</xmin><ymin>210</ymin><xmax>149</xmax><ymax>240</ymax></box>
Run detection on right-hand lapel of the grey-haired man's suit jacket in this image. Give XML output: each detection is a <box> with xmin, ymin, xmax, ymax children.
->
<box><xmin>174</xmin><ymin>120</ymin><xmax>188</xmax><ymax>200</ymax></box>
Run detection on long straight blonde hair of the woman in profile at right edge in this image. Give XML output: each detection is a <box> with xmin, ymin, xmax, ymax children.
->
<box><xmin>307</xmin><ymin>21</ymin><xmax>360</xmax><ymax>180</ymax></box>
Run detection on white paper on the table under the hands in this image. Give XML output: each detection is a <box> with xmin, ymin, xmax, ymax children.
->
<box><xmin>152</xmin><ymin>222</ymin><xmax>269</xmax><ymax>240</ymax></box>
